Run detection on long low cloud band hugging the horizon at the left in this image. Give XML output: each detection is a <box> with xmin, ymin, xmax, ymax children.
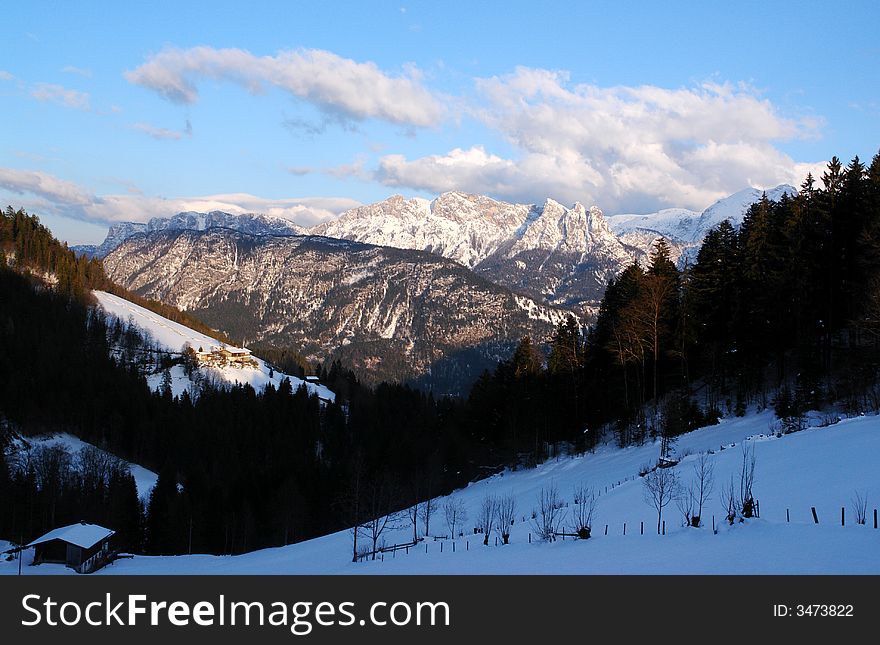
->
<box><xmin>0</xmin><ymin>168</ymin><xmax>360</xmax><ymax>226</ymax></box>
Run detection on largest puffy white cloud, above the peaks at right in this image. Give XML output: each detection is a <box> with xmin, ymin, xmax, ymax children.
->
<box><xmin>375</xmin><ymin>68</ymin><xmax>821</xmax><ymax>212</ymax></box>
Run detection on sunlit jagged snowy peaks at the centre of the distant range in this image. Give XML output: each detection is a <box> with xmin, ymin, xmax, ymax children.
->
<box><xmin>310</xmin><ymin>192</ymin><xmax>632</xmax><ymax>310</ymax></box>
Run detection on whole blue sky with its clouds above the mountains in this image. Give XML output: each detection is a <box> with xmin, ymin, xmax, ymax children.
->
<box><xmin>0</xmin><ymin>1</ymin><xmax>880</xmax><ymax>243</ymax></box>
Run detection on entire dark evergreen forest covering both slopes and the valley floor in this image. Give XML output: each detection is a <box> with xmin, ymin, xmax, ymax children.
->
<box><xmin>0</xmin><ymin>150</ymin><xmax>880</xmax><ymax>553</ymax></box>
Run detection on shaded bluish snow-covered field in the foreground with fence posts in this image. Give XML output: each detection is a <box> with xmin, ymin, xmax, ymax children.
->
<box><xmin>0</xmin><ymin>412</ymin><xmax>880</xmax><ymax>575</ymax></box>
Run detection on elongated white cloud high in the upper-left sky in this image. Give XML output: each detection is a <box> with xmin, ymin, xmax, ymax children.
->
<box><xmin>125</xmin><ymin>46</ymin><xmax>444</xmax><ymax>126</ymax></box>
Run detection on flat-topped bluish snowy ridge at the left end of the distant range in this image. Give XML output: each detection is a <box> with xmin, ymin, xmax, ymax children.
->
<box><xmin>72</xmin><ymin>211</ymin><xmax>305</xmax><ymax>258</ymax></box>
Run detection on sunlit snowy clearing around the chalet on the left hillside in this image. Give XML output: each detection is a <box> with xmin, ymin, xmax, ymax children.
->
<box><xmin>92</xmin><ymin>291</ymin><xmax>336</xmax><ymax>401</ymax></box>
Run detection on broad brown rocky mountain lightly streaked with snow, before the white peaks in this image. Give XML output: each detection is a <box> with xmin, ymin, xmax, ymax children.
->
<box><xmin>104</xmin><ymin>228</ymin><xmax>567</xmax><ymax>391</ymax></box>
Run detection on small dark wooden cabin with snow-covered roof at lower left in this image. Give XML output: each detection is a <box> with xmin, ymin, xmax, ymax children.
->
<box><xmin>27</xmin><ymin>522</ymin><xmax>116</xmax><ymax>573</ymax></box>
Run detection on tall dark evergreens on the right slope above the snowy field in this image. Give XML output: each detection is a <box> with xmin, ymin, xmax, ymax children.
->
<box><xmin>469</xmin><ymin>154</ymin><xmax>880</xmax><ymax>452</ymax></box>
